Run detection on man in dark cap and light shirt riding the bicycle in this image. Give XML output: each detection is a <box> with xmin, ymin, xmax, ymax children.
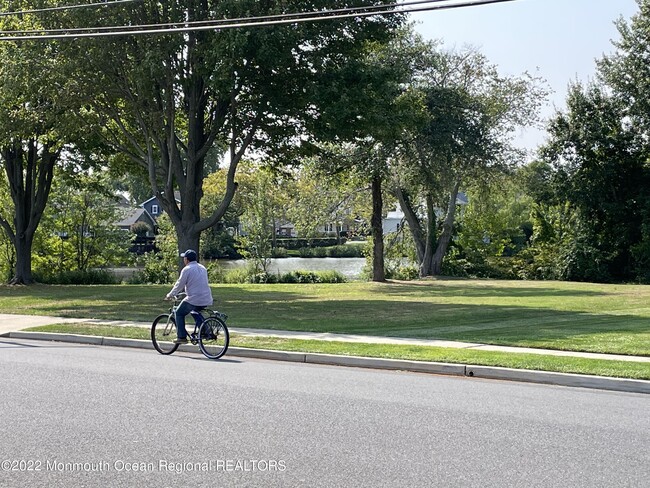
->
<box><xmin>165</xmin><ymin>249</ymin><xmax>213</xmax><ymax>344</ymax></box>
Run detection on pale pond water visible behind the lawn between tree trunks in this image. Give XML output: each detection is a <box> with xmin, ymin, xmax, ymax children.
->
<box><xmin>213</xmin><ymin>258</ymin><xmax>366</xmax><ymax>280</ymax></box>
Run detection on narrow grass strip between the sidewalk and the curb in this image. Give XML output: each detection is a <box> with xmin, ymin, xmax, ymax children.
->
<box><xmin>25</xmin><ymin>324</ymin><xmax>650</xmax><ymax>380</ymax></box>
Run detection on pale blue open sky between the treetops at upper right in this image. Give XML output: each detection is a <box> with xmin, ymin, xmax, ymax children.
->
<box><xmin>411</xmin><ymin>0</ymin><xmax>638</xmax><ymax>150</ymax></box>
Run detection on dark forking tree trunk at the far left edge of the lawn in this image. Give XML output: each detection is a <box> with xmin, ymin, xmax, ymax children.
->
<box><xmin>0</xmin><ymin>139</ymin><xmax>59</xmax><ymax>285</ymax></box>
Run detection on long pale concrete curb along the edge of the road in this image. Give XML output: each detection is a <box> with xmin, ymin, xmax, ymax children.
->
<box><xmin>6</xmin><ymin>331</ymin><xmax>650</xmax><ymax>394</ymax></box>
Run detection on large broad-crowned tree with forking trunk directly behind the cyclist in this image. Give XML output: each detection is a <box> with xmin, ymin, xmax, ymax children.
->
<box><xmin>62</xmin><ymin>0</ymin><xmax>402</xmax><ymax>264</ymax></box>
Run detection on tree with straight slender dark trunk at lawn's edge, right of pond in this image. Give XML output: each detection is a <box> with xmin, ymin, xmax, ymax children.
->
<box><xmin>302</xmin><ymin>28</ymin><xmax>420</xmax><ymax>282</ymax></box>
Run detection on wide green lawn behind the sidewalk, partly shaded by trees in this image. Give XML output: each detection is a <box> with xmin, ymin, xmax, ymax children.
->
<box><xmin>0</xmin><ymin>280</ymin><xmax>650</xmax><ymax>356</ymax></box>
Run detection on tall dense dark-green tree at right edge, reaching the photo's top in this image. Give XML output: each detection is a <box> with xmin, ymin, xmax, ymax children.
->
<box><xmin>543</xmin><ymin>0</ymin><xmax>650</xmax><ymax>281</ymax></box>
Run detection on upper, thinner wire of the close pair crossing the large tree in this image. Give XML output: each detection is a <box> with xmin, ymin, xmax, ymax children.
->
<box><xmin>0</xmin><ymin>0</ymin><xmax>450</xmax><ymax>35</ymax></box>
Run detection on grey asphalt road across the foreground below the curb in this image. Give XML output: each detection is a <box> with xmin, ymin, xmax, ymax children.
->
<box><xmin>0</xmin><ymin>338</ymin><xmax>650</xmax><ymax>488</ymax></box>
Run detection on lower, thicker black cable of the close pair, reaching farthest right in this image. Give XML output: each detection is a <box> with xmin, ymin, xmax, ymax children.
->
<box><xmin>0</xmin><ymin>0</ymin><xmax>516</xmax><ymax>41</ymax></box>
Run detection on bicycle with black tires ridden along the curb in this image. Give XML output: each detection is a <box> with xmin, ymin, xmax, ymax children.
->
<box><xmin>151</xmin><ymin>296</ymin><xmax>230</xmax><ymax>359</ymax></box>
